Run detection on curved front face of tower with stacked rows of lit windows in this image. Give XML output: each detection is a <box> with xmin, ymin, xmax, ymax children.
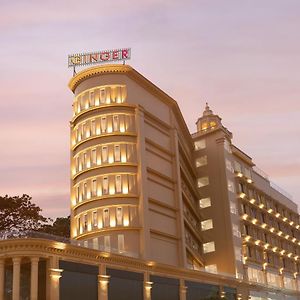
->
<box><xmin>71</xmin><ymin>69</ymin><xmax>139</xmax><ymax>255</ymax></box>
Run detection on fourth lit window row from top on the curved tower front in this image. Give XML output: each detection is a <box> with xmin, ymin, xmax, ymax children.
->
<box><xmin>75</xmin><ymin>174</ymin><xmax>137</xmax><ymax>203</ymax></box>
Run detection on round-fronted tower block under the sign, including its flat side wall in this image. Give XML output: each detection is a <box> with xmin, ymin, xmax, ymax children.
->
<box><xmin>69</xmin><ymin>65</ymin><xmax>203</xmax><ymax>269</ymax></box>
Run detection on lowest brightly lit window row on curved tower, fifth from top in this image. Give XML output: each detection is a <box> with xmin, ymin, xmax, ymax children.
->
<box><xmin>76</xmin><ymin>206</ymin><xmax>137</xmax><ymax>235</ymax></box>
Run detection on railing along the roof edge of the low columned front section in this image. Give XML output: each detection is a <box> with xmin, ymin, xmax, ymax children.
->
<box><xmin>0</xmin><ymin>230</ymin><xmax>139</xmax><ymax>258</ymax></box>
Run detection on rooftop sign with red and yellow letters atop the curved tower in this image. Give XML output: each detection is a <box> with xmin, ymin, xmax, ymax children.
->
<box><xmin>68</xmin><ymin>48</ymin><xmax>131</xmax><ymax>67</ymax></box>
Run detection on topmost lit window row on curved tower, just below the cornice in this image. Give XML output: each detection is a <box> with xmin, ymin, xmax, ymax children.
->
<box><xmin>73</xmin><ymin>85</ymin><xmax>126</xmax><ymax>115</ymax></box>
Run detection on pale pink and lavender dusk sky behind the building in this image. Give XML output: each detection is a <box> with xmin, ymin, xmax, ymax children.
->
<box><xmin>0</xmin><ymin>0</ymin><xmax>300</xmax><ymax>217</ymax></box>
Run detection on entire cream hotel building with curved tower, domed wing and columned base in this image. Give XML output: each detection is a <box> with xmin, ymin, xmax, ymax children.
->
<box><xmin>0</xmin><ymin>65</ymin><xmax>300</xmax><ymax>300</ymax></box>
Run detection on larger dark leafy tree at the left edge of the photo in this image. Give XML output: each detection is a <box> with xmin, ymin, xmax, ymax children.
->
<box><xmin>0</xmin><ymin>194</ymin><xmax>50</xmax><ymax>232</ymax></box>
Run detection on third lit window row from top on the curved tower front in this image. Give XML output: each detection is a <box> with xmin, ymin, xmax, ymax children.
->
<box><xmin>73</xmin><ymin>144</ymin><xmax>136</xmax><ymax>175</ymax></box>
